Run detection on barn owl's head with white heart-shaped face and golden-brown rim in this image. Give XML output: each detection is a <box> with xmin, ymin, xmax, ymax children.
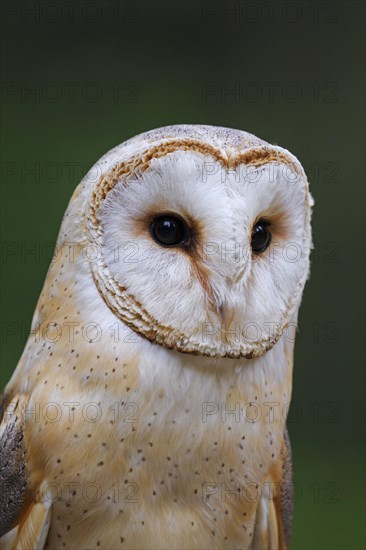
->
<box><xmin>82</xmin><ymin>125</ymin><xmax>312</xmax><ymax>358</ymax></box>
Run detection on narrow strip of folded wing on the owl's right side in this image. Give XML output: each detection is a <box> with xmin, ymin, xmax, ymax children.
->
<box><xmin>252</xmin><ymin>429</ymin><xmax>293</xmax><ymax>550</ymax></box>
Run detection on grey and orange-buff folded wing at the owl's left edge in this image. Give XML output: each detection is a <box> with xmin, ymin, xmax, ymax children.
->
<box><xmin>0</xmin><ymin>395</ymin><xmax>51</xmax><ymax>550</ymax></box>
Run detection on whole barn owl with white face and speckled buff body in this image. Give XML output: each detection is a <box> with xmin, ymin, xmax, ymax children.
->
<box><xmin>0</xmin><ymin>125</ymin><xmax>313</xmax><ymax>550</ymax></box>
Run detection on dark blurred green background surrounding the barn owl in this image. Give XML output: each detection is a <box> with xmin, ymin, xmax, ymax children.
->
<box><xmin>0</xmin><ymin>0</ymin><xmax>366</xmax><ymax>549</ymax></box>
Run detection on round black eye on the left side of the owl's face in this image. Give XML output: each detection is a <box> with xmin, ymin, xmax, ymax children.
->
<box><xmin>150</xmin><ymin>214</ymin><xmax>189</xmax><ymax>246</ymax></box>
